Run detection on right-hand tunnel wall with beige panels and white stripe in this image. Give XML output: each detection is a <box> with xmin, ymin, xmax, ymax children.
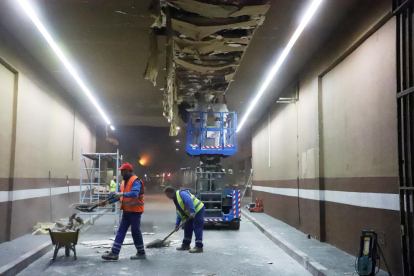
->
<box><xmin>252</xmin><ymin>1</ymin><xmax>402</xmax><ymax>275</ymax></box>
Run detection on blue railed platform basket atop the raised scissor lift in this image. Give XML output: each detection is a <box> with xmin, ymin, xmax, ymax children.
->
<box><xmin>187</xmin><ymin>111</ymin><xmax>237</xmax><ymax>156</ymax></box>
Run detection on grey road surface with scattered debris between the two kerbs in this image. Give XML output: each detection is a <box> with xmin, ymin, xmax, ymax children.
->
<box><xmin>19</xmin><ymin>195</ymin><xmax>310</xmax><ymax>276</ymax></box>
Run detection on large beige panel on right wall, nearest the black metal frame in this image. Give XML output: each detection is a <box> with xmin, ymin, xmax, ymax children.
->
<box><xmin>322</xmin><ymin>19</ymin><xmax>398</xmax><ymax>177</ymax></box>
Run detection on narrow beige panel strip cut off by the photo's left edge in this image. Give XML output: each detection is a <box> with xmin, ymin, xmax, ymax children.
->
<box><xmin>0</xmin><ymin>64</ymin><xmax>15</xmax><ymax>178</ymax></box>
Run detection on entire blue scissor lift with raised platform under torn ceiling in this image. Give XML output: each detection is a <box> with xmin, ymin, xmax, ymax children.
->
<box><xmin>187</xmin><ymin>111</ymin><xmax>241</xmax><ymax>230</ymax></box>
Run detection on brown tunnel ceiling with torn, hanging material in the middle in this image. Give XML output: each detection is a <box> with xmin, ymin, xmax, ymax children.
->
<box><xmin>0</xmin><ymin>0</ymin><xmax>362</xmax><ymax>134</ymax></box>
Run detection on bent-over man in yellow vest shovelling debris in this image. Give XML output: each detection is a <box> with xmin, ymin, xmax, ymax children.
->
<box><xmin>164</xmin><ymin>186</ymin><xmax>204</xmax><ymax>253</ymax></box>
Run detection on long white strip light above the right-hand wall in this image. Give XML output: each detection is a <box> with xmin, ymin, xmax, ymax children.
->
<box><xmin>236</xmin><ymin>0</ymin><xmax>322</xmax><ymax>132</ymax></box>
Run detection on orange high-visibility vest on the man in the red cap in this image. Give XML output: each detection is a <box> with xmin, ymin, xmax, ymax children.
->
<box><xmin>120</xmin><ymin>175</ymin><xmax>145</xmax><ymax>212</ymax></box>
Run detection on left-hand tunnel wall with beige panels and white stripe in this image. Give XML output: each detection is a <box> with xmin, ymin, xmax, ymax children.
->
<box><xmin>0</xmin><ymin>26</ymin><xmax>95</xmax><ymax>242</ymax></box>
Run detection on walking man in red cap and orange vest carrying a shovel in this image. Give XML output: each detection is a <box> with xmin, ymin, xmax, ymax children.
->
<box><xmin>100</xmin><ymin>163</ymin><xmax>147</xmax><ymax>261</ymax></box>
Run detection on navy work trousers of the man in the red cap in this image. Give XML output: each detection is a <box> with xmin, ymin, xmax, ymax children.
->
<box><xmin>112</xmin><ymin>211</ymin><xmax>145</xmax><ymax>254</ymax></box>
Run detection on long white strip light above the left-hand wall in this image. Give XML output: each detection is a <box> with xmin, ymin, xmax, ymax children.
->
<box><xmin>18</xmin><ymin>0</ymin><xmax>113</xmax><ymax>125</ymax></box>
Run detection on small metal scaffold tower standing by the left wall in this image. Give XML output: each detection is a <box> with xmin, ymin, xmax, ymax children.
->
<box><xmin>79</xmin><ymin>150</ymin><xmax>122</xmax><ymax>215</ymax></box>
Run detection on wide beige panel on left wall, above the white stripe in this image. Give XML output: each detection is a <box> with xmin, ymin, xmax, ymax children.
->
<box><xmin>15</xmin><ymin>75</ymin><xmax>73</xmax><ymax>178</ymax></box>
